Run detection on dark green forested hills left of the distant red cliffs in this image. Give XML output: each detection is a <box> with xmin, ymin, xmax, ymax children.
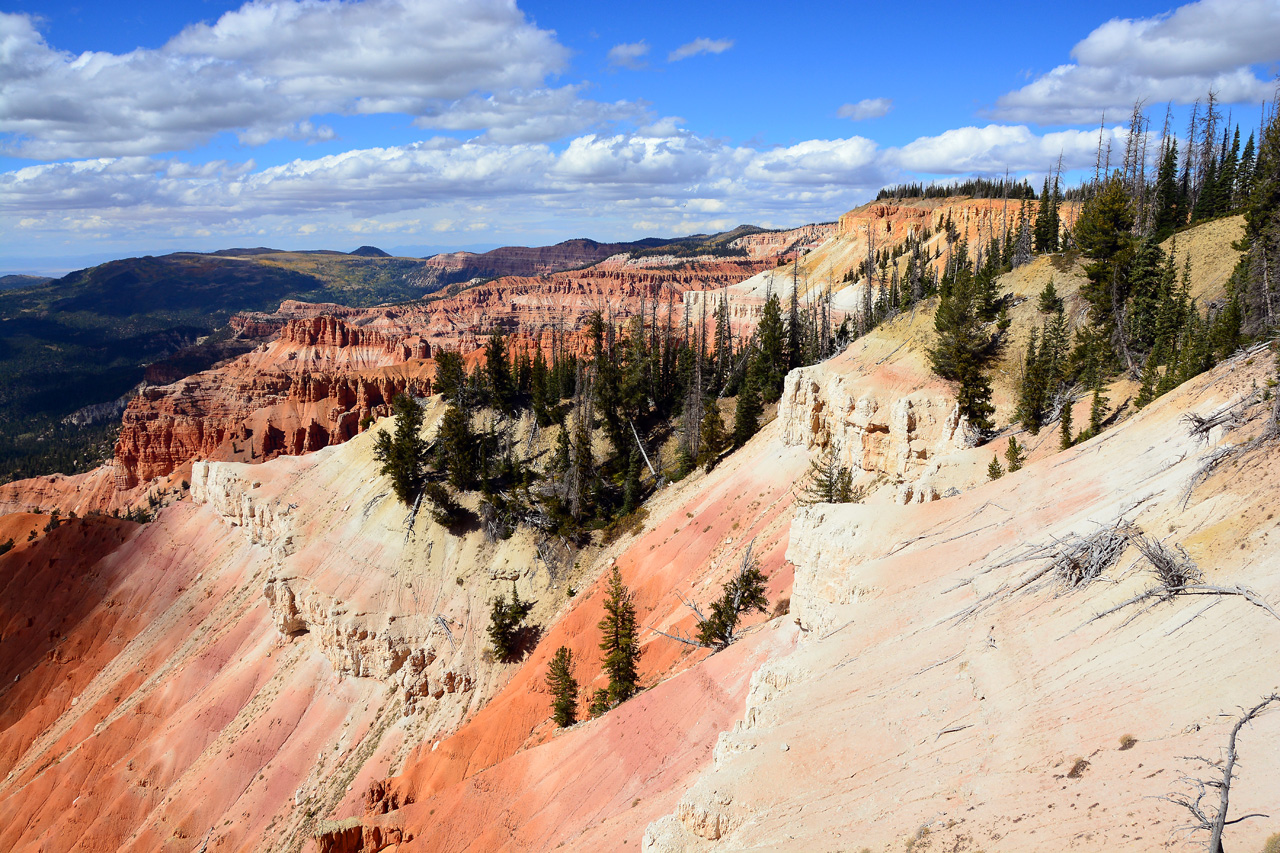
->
<box><xmin>0</xmin><ymin>254</ymin><xmax>435</xmax><ymax>482</ymax></box>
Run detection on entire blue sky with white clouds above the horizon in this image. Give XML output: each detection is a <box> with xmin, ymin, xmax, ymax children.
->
<box><xmin>0</xmin><ymin>0</ymin><xmax>1280</xmax><ymax>272</ymax></box>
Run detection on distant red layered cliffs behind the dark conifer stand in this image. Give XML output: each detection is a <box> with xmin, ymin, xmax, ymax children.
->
<box><xmin>115</xmin><ymin>260</ymin><xmax>763</xmax><ymax>489</ymax></box>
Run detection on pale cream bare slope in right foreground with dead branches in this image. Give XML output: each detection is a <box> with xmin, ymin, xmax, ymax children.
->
<box><xmin>645</xmin><ymin>350</ymin><xmax>1280</xmax><ymax>853</ymax></box>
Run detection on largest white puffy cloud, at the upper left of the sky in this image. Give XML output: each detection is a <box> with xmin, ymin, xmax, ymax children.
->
<box><xmin>0</xmin><ymin>0</ymin><xmax>586</xmax><ymax>160</ymax></box>
